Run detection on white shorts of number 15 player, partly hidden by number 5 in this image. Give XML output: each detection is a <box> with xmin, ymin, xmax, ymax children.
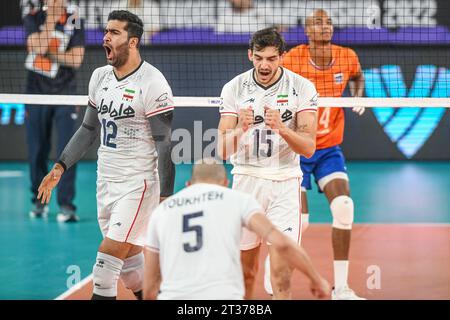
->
<box><xmin>233</xmin><ymin>174</ymin><xmax>302</xmax><ymax>250</ymax></box>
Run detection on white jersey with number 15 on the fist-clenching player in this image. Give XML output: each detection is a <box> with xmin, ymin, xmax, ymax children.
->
<box><xmin>220</xmin><ymin>68</ymin><xmax>317</xmax><ymax>181</ymax></box>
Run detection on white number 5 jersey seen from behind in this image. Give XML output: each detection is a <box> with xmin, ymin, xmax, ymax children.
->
<box><xmin>146</xmin><ymin>183</ymin><xmax>263</xmax><ymax>300</ymax></box>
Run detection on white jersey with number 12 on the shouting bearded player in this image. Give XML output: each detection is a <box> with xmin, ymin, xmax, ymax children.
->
<box><xmin>89</xmin><ymin>61</ymin><xmax>174</xmax><ymax>181</ymax></box>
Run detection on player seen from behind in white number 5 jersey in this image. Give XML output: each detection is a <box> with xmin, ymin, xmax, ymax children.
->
<box><xmin>143</xmin><ymin>159</ymin><xmax>330</xmax><ymax>300</ymax></box>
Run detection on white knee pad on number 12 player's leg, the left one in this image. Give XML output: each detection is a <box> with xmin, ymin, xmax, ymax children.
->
<box><xmin>92</xmin><ymin>252</ymin><xmax>123</xmax><ymax>297</ymax></box>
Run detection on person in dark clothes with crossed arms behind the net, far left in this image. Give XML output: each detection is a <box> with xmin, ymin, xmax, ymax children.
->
<box><xmin>22</xmin><ymin>0</ymin><xmax>84</xmax><ymax>222</ymax></box>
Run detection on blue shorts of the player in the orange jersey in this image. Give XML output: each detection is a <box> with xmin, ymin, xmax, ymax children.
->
<box><xmin>300</xmin><ymin>146</ymin><xmax>348</xmax><ymax>192</ymax></box>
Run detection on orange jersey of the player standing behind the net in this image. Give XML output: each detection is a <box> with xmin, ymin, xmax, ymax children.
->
<box><xmin>283</xmin><ymin>44</ymin><xmax>361</xmax><ymax>149</ymax></box>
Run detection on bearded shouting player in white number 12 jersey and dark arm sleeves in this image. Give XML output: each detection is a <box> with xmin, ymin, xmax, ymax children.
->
<box><xmin>39</xmin><ymin>10</ymin><xmax>175</xmax><ymax>299</ymax></box>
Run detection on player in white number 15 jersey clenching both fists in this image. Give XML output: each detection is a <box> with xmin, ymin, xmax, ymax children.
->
<box><xmin>218</xmin><ymin>28</ymin><xmax>317</xmax><ymax>299</ymax></box>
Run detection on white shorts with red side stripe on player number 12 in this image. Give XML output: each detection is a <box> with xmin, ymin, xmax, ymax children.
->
<box><xmin>97</xmin><ymin>179</ymin><xmax>159</xmax><ymax>246</ymax></box>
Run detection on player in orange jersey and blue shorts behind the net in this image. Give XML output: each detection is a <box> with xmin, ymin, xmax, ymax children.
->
<box><xmin>280</xmin><ymin>9</ymin><xmax>364</xmax><ymax>300</ymax></box>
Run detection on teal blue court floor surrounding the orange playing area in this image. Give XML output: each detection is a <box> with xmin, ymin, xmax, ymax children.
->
<box><xmin>0</xmin><ymin>162</ymin><xmax>450</xmax><ymax>299</ymax></box>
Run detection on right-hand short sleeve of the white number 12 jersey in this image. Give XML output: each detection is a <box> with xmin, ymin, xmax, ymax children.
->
<box><xmin>144</xmin><ymin>75</ymin><xmax>175</xmax><ymax>118</ymax></box>
